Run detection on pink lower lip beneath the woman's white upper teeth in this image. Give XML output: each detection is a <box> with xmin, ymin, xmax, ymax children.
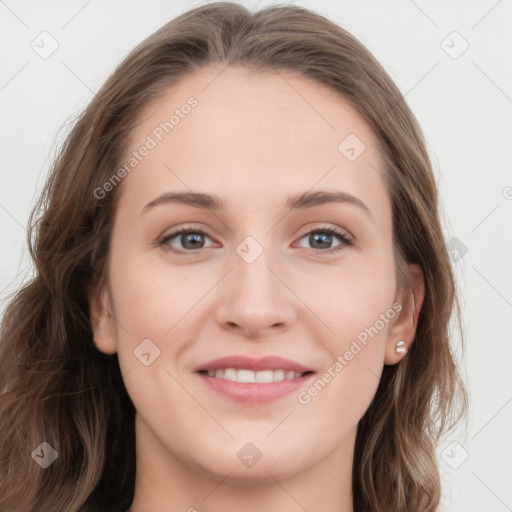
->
<box><xmin>198</xmin><ymin>373</ymin><xmax>314</xmax><ymax>404</ymax></box>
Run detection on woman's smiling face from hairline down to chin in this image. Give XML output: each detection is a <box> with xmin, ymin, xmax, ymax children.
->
<box><xmin>92</xmin><ymin>67</ymin><xmax>420</xmax><ymax>486</ymax></box>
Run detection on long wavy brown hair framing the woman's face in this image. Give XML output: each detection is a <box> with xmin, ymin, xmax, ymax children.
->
<box><xmin>0</xmin><ymin>2</ymin><xmax>466</xmax><ymax>512</ymax></box>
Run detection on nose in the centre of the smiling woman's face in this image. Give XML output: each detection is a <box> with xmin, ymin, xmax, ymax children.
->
<box><xmin>216</xmin><ymin>245</ymin><xmax>296</xmax><ymax>339</ymax></box>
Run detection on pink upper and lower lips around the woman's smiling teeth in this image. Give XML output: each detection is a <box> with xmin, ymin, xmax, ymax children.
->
<box><xmin>195</xmin><ymin>356</ymin><xmax>315</xmax><ymax>404</ymax></box>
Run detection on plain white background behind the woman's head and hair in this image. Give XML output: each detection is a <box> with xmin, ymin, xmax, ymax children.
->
<box><xmin>0</xmin><ymin>0</ymin><xmax>512</xmax><ymax>512</ymax></box>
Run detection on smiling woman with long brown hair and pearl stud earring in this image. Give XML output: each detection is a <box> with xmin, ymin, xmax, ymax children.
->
<box><xmin>0</xmin><ymin>2</ymin><xmax>466</xmax><ymax>512</ymax></box>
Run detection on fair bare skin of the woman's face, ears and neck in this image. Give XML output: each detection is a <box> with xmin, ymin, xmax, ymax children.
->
<box><xmin>91</xmin><ymin>67</ymin><xmax>424</xmax><ymax>512</ymax></box>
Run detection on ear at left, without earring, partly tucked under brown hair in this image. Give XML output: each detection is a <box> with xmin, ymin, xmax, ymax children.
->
<box><xmin>89</xmin><ymin>288</ymin><xmax>117</xmax><ymax>354</ymax></box>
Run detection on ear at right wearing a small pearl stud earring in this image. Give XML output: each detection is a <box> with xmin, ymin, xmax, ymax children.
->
<box><xmin>384</xmin><ymin>265</ymin><xmax>425</xmax><ymax>364</ymax></box>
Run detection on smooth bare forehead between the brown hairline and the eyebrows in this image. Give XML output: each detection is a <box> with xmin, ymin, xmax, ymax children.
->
<box><xmin>116</xmin><ymin>66</ymin><xmax>385</xmax><ymax>219</ymax></box>
